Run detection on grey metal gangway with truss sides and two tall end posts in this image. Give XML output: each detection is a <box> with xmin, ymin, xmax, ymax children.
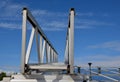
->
<box><xmin>21</xmin><ymin>8</ymin><xmax>75</xmax><ymax>74</ymax></box>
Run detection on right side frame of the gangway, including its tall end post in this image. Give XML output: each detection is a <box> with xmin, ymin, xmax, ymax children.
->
<box><xmin>65</xmin><ymin>8</ymin><xmax>75</xmax><ymax>74</ymax></box>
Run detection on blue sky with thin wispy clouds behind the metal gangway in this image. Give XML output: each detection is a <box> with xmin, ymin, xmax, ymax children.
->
<box><xmin>0</xmin><ymin>0</ymin><xmax>120</xmax><ymax>70</ymax></box>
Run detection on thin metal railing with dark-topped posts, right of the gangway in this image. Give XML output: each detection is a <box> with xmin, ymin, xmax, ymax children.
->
<box><xmin>74</xmin><ymin>66</ymin><xmax>120</xmax><ymax>82</ymax></box>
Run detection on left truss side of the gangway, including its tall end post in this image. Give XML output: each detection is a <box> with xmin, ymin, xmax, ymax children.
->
<box><xmin>21</xmin><ymin>8</ymin><xmax>58</xmax><ymax>74</ymax></box>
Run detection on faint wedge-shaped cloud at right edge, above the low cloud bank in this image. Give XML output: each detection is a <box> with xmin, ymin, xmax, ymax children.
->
<box><xmin>88</xmin><ymin>41</ymin><xmax>120</xmax><ymax>51</ymax></box>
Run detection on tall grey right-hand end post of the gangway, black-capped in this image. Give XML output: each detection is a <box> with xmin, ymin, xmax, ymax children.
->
<box><xmin>69</xmin><ymin>8</ymin><xmax>75</xmax><ymax>74</ymax></box>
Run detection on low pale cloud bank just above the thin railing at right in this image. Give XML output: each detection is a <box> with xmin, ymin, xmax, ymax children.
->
<box><xmin>75</xmin><ymin>54</ymin><xmax>120</xmax><ymax>67</ymax></box>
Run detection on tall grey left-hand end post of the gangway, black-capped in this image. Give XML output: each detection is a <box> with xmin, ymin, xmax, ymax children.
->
<box><xmin>21</xmin><ymin>8</ymin><xmax>27</xmax><ymax>74</ymax></box>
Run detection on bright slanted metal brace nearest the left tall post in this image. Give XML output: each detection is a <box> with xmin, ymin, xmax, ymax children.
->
<box><xmin>25</xmin><ymin>28</ymin><xmax>35</xmax><ymax>64</ymax></box>
